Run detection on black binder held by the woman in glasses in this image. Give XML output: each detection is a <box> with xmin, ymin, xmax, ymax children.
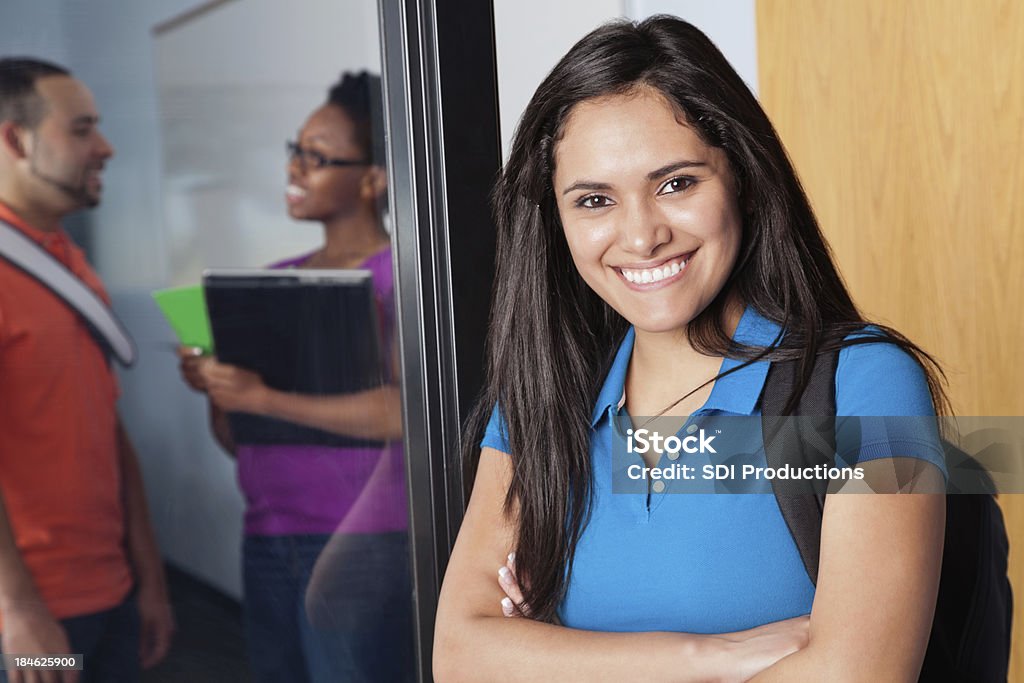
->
<box><xmin>203</xmin><ymin>269</ymin><xmax>386</xmax><ymax>447</ymax></box>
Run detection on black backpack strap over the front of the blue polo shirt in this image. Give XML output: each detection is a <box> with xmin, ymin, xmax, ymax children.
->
<box><xmin>761</xmin><ymin>350</ymin><xmax>839</xmax><ymax>585</ymax></box>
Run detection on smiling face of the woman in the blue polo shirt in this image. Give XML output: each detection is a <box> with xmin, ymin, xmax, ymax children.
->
<box><xmin>553</xmin><ymin>87</ymin><xmax>742</xmax><ymax>332</ymax></box>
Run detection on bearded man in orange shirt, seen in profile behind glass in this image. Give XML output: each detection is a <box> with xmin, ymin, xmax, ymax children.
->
<box><xmin>0</xmin><ymin>58</ymin><xmax>174</xmax><ymax>681</ymax></box>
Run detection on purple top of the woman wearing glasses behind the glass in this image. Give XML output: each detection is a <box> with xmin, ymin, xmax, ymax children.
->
<box><xmin>238</xmin><ymin>249</ymin><xmax>409</xmax><ymax>536</ymax></box>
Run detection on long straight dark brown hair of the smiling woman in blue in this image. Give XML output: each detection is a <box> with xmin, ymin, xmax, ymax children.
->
<box><xmin>464</xmin><ymin>16</ymin><xmax>948</xmax><ymax>621</ymax></box>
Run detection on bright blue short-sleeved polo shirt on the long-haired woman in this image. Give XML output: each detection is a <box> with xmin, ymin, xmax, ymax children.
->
<box><xmin>481</xmin><ymin>307</ymin><xmax>942</xmax><ymax>633</ymax></box>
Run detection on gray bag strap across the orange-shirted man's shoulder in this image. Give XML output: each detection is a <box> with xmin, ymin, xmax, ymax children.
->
<box><xmin>0</xmin><ymin>220</ymin><xmax>136</xmax><ymax>368</ymax></box>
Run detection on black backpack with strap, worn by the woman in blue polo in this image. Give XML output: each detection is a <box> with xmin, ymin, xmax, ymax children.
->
<box><xmin>761</xmin><ymin>350</ymin><xmax>1013</xmax><ymax>683</ymax></box>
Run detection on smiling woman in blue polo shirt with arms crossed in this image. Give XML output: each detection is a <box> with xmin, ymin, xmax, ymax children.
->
<box><xmin>434</xmin><ymin>16</ymin><xmax>946</xmax><ymax>681</ymax></box>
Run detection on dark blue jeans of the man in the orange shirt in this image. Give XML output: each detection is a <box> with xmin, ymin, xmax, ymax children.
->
<box><xmin>0</xmin><ymin>593</ymin><xmax>140</xmax><ymax>683</ymax></box>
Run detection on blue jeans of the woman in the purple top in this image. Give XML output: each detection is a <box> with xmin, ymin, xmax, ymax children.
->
<box><xmin>243</xmin><ymin>532</ymin><xmax>414</xmax><ymax>683</ymax></box>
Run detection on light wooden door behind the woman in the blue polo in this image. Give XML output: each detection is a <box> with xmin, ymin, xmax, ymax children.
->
<box><xmin>758</xmin><ymin>0</ymin><xmax>1024</xmax><ymax>681</ymax></box>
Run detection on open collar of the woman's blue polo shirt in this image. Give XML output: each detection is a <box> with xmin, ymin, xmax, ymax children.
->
<box><xmin>590</xmin><ymin>306</ymin><xmax>781</xmax><ymax>427</ymax></box>
